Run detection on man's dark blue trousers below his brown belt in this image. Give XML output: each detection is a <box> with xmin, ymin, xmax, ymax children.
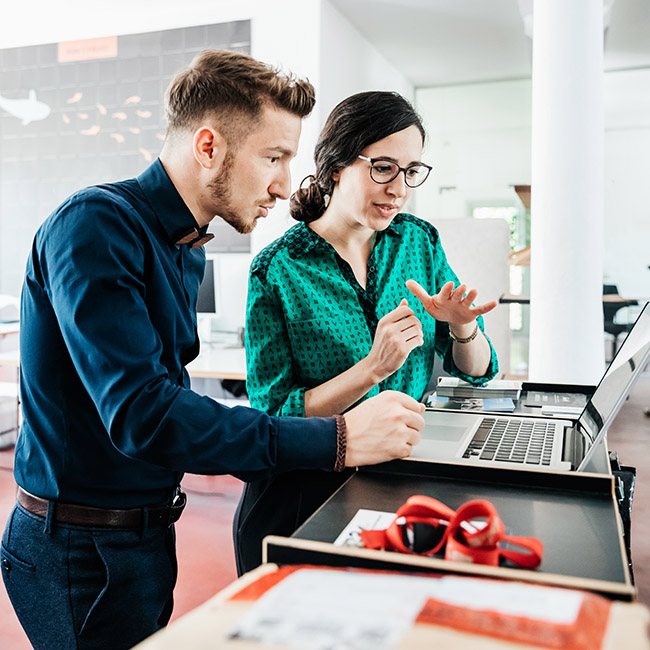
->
<box><xmin>1</xmin><ymin>505</ymin><xmax>177</xmax><ymax>650</ymax></box>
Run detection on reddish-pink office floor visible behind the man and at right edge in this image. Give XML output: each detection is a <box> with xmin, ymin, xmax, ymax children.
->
<box><xmin>0</xmin><ymin>373</ymin><xmax>650</xmax><ymax>650</ymax></box>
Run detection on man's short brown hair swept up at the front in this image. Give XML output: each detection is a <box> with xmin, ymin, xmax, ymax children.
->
<box><xmin>165</xmin><ymin>50</ymin><xmax>315</xmax><ymax>142</ymax></box>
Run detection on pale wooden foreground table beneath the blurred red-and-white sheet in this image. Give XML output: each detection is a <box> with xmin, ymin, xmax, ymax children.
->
<box><xmin>134</xmin><ymin>564</ymin><xmax>650</xmax><ymax>650</ymax></box>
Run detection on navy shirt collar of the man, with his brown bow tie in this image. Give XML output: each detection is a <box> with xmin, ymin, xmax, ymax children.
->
<box><xmin>137</xmin><ymin>158</ymin><xmax>214</xmax><ymax>247</ymax></box>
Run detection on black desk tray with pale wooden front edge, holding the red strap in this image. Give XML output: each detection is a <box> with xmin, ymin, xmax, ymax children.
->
<box><xmin>263</xmin><ymin>460</ymin><xmax>635</xmax><ymax>600</ymax></box>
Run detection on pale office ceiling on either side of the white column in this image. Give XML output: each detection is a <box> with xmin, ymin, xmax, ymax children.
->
<box><xmin>330</xmin><ymin>0</ymin><xmax>650</xmax><ymax>87</ymax></box>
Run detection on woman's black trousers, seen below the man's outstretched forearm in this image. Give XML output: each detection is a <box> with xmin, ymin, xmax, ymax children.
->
<box><xmin>233</xmin><ymin>469</ymin><xmax>354</xmax><ymax>576</ymax></box>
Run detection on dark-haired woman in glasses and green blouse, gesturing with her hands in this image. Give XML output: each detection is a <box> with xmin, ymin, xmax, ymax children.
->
<box><xmin>235</xmin><ymin>92</ymin><xmax>498</xmax><ymax>570</ymax></box>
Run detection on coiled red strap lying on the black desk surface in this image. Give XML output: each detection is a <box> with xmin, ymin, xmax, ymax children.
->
<box><xmin>361</xmin><ymin>495</ymin><xmax>544</xmax><ymax>569</ymax></box>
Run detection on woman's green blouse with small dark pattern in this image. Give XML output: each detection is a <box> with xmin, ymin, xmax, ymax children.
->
<box><xmin>246</xmin><ymin>214</ymin><xmax>498</xmax><ymax>417</ymax></box>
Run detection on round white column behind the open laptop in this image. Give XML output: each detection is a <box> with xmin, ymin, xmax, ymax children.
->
<box><xmin>529</xmin><ymin>0</ymin><xmax>605</xmax><ymax>384</ymax></box>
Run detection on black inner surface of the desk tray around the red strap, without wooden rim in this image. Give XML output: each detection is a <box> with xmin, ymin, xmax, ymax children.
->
<box><xmin>292</xmin><ymin>461</ymin><xmax>627</xmax><ymax>584</ymax></box>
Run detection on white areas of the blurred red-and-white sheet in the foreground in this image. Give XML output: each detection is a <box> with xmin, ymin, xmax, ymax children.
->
<box><xmin>231</xmin><ymin>569</ymin><xmax>583</xmax><ymax>650</ymax></box>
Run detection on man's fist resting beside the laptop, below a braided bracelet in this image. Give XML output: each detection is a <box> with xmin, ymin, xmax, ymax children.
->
<box><xmin>344</xmin><ymin>390</ymin><xmax>424</xmax><ymax>467</ymax></box>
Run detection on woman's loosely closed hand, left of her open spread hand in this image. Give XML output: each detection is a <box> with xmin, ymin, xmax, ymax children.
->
<box><xmin>366</xmin><ymin>299</ymin><xmax>424</xmax><ymax>384</ymax></box>
